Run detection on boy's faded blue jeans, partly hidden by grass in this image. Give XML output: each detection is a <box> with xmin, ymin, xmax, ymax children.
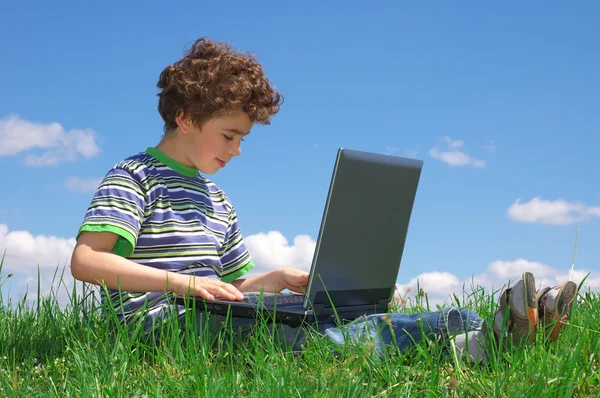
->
<box><xmin>146</xmin><ymin>306</ymin><xmax>483</xmax><ymax>354</ymax></box>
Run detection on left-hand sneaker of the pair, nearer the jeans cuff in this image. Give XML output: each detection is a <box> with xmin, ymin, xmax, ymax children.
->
<box><xmin>494</xmin><ymin>272</ymin><xmax>538</xmax><ymax>343</ymax></box>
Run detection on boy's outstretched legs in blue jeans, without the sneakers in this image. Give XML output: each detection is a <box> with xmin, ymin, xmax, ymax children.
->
<box><xmin>171</xmin><ymin>307</ymin><xmax>485</xmax><ymax>361</ymax></box>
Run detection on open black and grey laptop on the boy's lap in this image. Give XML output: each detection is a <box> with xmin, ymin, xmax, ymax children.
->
<box><xmin>178</xmin><ymin>148</ymin><xmax>423</xmax><ymax>325</ymax></box>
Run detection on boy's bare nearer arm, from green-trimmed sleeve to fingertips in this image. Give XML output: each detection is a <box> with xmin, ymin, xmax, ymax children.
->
<box><xmin>71</xmin><ymin>232</ymin><xmax>243</xmax><ymax>300</ymax></box>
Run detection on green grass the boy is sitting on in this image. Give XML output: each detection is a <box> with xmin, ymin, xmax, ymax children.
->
<box><xmin>0</xmin><ymin>262</ymin><xmax>600</xmax><ymax>397</ymax></box>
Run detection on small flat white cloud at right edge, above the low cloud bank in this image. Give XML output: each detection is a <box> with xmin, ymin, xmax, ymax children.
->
<box><xmin>507</xmin><ymin>197</ymin><xmax>600</xmax><ymax>225</ymax></box>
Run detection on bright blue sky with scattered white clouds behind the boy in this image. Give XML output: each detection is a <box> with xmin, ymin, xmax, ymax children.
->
<box><xmin>0</xmin><ymin>1</ymin><xmax>600</xmax><ymax>304</ymax></box>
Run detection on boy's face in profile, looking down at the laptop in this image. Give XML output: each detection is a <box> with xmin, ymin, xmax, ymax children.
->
<box><xmin>178</xmin><ymin>111</ymin><xmax>254</xmax><ymax>174</ymax></box>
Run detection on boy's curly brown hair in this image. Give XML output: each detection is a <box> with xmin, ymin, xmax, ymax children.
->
<box><xmin>157</xmin><ymin>38</ymin><xmax>283</xmax><ymax>133</ymax></box>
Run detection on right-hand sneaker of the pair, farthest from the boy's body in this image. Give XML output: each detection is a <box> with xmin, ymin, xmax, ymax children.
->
<box><xmin>537</xmin><ymin>281</ymin><xmax>577</xmax><ymax>341</ymax></box>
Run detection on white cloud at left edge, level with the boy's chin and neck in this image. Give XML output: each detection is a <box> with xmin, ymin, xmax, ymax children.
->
<box><xmin>0</xmin><ymin>115</ymin><xmax>100</xmax><ymax>166</ymax></box>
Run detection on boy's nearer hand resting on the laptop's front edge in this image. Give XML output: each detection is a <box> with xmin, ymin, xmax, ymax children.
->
<box><xmin>173</xmin><ymin>274</ymin><xmax>244</xmax><ymax>301</ymax></box>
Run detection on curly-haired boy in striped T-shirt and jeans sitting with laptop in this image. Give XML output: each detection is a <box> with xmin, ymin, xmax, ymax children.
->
<box><xmin>71</xmin><ymin>39</ymin><xmax>573</xmax><ymax>356</ymax></box>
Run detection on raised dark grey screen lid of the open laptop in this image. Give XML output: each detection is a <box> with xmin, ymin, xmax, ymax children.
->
<box><xmin>304</xmin><ymin>148</ymin><xmax>423</xmax><ymax>311</ymax></box>
